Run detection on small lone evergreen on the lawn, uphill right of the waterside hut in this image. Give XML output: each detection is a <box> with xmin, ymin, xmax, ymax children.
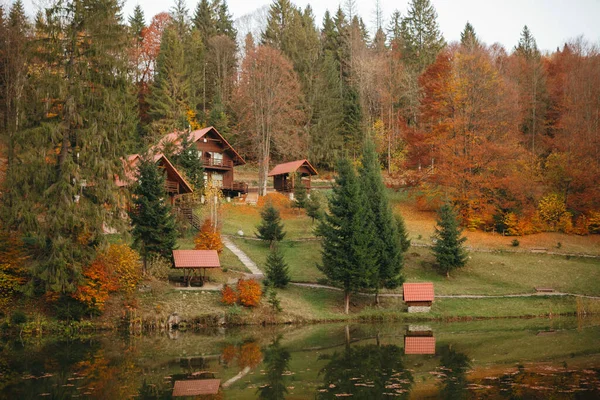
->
<box><xmin>433</xmin><ymin>203</ymin><xmax>468</xmax><ymax>277</ymax></box>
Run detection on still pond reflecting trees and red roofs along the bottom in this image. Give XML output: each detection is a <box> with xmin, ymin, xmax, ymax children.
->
<box><xmin>0</xmin><ymin>318</ymin><xmax>600</xmax><ymax>400</ymax></box>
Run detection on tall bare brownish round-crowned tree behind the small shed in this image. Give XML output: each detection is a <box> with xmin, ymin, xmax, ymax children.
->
<box><xmin>235</xmin><ymin>46</ymin><xmax>306</xmax><ymax>196</ymax></box>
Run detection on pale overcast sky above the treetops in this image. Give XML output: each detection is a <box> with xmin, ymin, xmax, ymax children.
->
<box><xmin>17</xmin><ymin>0</ymin><xmax>600</xmax><ymax>51</ymax></box>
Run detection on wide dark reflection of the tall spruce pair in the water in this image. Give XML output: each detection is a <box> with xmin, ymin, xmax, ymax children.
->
<box><xmin>317</xmin><ymin>345</ymin><xmax>413</xmax><ymax>399</ymax></box>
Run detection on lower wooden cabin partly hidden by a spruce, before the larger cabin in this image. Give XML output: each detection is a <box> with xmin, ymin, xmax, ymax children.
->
<box><xmin>116</xmin><ymin>154</ymin><xmax>192</xmax><ymax>204</ymax></box>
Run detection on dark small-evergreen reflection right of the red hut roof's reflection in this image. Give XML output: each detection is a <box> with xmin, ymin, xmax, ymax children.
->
<box><xmin>438</xmin><ymin>346</ymin><xmax>471</xmax><ymax>400</ymax></box>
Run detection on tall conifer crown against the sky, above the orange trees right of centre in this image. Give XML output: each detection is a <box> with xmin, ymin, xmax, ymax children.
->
<box><xmin>402</xmin><ymin>0</ymin><xmax>446</xmax><ymax>72</ymax></box>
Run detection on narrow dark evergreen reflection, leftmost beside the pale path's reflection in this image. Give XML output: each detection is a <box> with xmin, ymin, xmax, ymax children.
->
<box><xmin>258</xmin><ymin>338</ymin><xmax>290</xmax><ymax>400</ymax></box>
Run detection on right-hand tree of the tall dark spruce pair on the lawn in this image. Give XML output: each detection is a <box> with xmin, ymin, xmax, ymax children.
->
<box><xmin>359</xmin><ymin>141</ymin><xmax>404</xmax><ymax>302</ymax></box>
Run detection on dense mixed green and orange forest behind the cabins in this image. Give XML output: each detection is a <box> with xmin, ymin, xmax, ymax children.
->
<box><xmin>0</xmin><ymin>0</ymin><xmax>600</xmax><ymax>291</ymax></box>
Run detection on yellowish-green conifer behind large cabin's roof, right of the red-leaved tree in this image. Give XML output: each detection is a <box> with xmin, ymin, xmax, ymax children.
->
<box><xmin>148</xmin><ymin>27</ymin><xmax>189</xmax><ymax>134</ymax></box>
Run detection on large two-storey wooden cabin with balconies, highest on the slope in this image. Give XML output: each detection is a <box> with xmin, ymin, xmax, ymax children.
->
<box><xmin>159</xmin><ymin>126</ymin><xmax>248</xmax><ymax>194</ymax></box>
